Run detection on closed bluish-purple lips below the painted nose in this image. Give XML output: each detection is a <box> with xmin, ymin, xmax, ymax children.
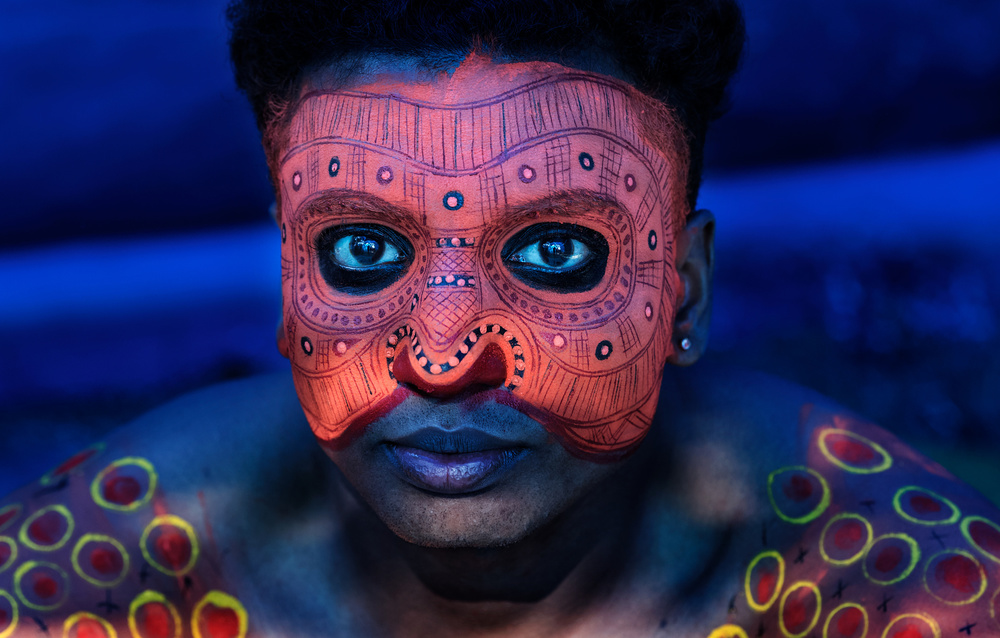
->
<box><xmin>385</xmin><ymin>428</ymin><xmax>528</xmax><ymax>494</ymax></box>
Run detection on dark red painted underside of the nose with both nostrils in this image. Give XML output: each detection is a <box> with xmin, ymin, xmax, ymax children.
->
<box><xmin>392</xmin><ymin>343</ymin><xmax>507</xmax><ymax>398</ymax></box>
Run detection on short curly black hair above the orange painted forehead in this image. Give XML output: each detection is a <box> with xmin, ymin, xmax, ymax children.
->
<box><xmin>227</xmin><ymin>0</ymin><xmax>745</xmax><ymax>209</ymax></box>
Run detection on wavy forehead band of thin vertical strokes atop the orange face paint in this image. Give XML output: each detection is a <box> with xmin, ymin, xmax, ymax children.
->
<box><xmin>279</xmin><ymin>74</ymin><xmax>672</xmax><ymax>170</ymax></box>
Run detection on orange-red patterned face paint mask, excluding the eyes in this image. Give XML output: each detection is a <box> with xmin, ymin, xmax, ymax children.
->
<box><xmin>278</xmin><ymin>73</ymin><xmax>684</xmax><ymax>460</ymax></box>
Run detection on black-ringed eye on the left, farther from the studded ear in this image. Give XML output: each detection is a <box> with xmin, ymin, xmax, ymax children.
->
<box><xmin>316</xmin><ymin>224</ymin><xmax>413</xmax><ymax>295</ymax></box>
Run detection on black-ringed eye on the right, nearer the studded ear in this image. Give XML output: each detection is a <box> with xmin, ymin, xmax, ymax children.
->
<box><xmin>500</xmin><ymin>222</ymin><xmax>608</xmax><ymax>292</ymax></box>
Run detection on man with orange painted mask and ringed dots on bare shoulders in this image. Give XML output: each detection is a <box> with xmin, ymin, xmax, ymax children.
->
<box><xmin>0</xmin><ymin>2</ymin><xmax>1000</xmax><ymax>638</ymax></box>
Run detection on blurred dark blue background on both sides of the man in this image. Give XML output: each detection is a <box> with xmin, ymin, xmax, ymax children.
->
<box><xmin>0</xmin><ymin>0</ymin><xmax>1000</xmax><ymax>501</ymax></box>
